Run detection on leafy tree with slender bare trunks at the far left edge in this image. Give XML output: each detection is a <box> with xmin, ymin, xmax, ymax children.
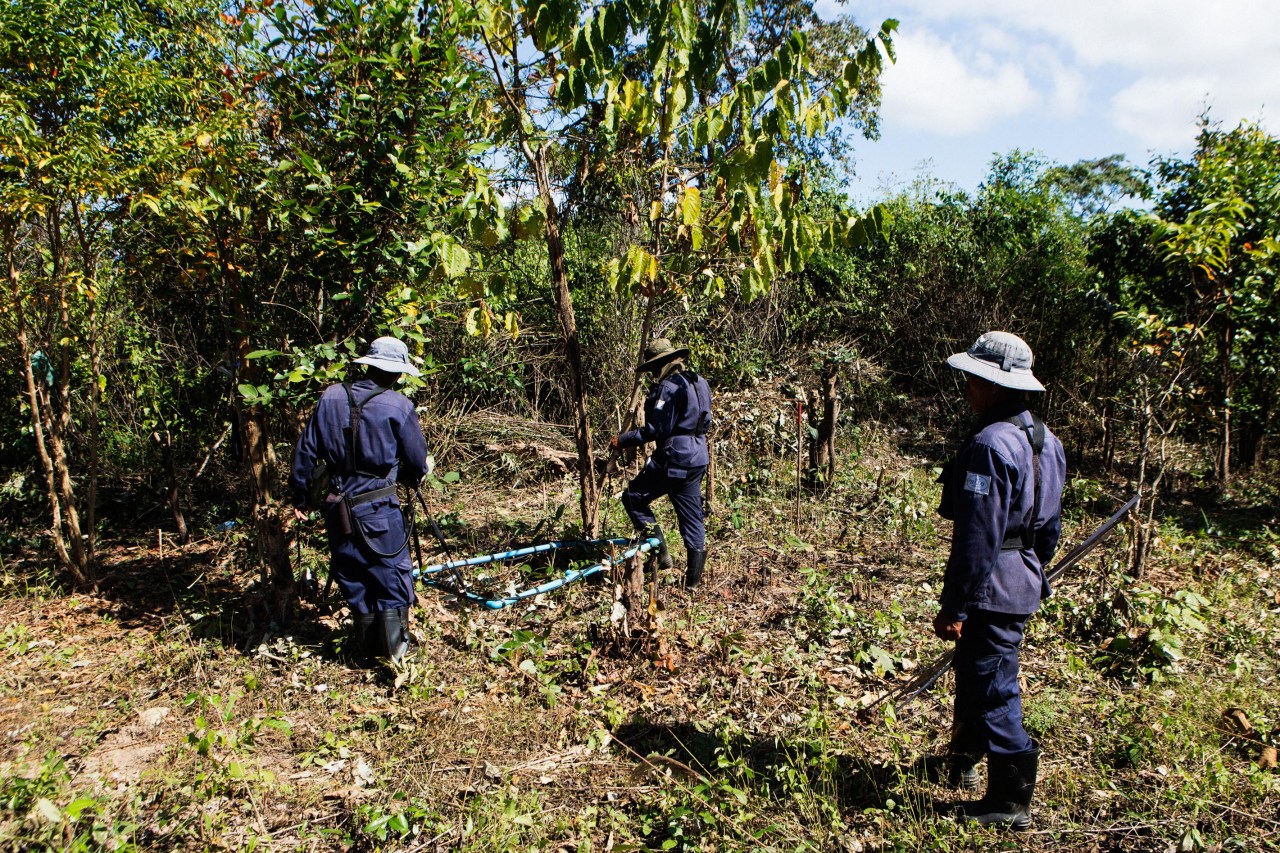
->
<box><xmin>0</xmin><ymin>0</ymin><xmax>221</xmax><ymax>583</ymax></box>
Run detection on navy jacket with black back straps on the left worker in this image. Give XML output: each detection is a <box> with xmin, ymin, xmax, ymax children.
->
<box><xmin>289</xmin><ymin>379</ymin><xmax>426</xmax><ymax>508</ymax></box>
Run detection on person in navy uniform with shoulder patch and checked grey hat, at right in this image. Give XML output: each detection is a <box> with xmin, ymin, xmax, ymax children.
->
<box><xmin>933</xmin><ymin>332</ymin><xmax>1066</xmax><ymax>830</ymax></box>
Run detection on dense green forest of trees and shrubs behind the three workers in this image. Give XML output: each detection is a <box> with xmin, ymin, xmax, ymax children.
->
<box><xmin>0</xmin><ymin>0</ymin><xmax>1280</xmax><ymax>845</ymax></box>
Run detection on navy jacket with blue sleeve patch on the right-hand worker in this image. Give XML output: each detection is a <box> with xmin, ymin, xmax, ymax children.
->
<box><xmin>938</xmin><ymin>405</ymin><xmax>1066</xmax><ymax>620</ymax></box>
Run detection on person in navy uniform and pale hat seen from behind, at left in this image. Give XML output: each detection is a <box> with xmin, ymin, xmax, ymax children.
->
<box><xmin>289</xmin><ymin>337</ymin><xmax>430</xmax><ymax>661</ymax></box>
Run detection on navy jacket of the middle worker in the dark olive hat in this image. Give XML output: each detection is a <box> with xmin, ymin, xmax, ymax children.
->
<box><xmin>618</xmin><ymin>370</ymin><xmax>712</xmax><ymax>476</ymax></box>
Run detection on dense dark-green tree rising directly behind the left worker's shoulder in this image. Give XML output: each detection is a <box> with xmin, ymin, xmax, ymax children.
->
<box><xmin>134</xmin><ymin>0</ymin><xmax>494</xmax><ymax>596</ymax></box>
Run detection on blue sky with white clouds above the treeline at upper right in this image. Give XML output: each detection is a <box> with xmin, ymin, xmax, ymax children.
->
<box><xmin>817</xmin><ymin>0</ymin><xmax>1280</xmax><ymax>204</ymax></box>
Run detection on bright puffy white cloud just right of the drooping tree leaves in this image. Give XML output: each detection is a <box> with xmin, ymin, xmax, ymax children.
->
<box><xmin>882</xmin><ymin>32</ymin><xmax>1037</xmax><ymax>136</ymax></box>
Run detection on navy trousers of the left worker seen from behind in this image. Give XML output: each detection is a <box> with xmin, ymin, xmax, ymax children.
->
<box><xmin>325</xmin><ymin>500</ymin><xmax>415</xmax><ymax>613</ymax></box>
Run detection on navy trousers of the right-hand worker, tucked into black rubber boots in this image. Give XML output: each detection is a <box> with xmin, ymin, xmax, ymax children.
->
<box><xmin>951</xmin><ymin>610</ymin><xmax>1032</xmax><ymax>756</ymax></box>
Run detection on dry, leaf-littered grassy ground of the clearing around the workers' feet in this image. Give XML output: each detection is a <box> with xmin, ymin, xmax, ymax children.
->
<box><xmin>0</xmin><ymin>417</ymin><xmax>1280</xmax><ymax>850</ymax></box>
